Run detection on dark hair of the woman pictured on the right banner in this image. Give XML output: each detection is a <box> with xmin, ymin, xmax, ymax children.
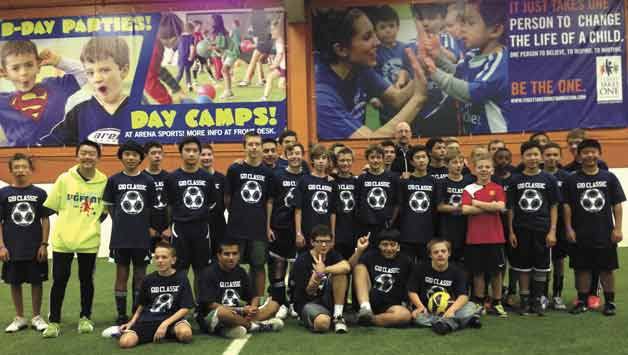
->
<box><xmin>312</xmin><ymin>7</ymin><xmax>366</xmax><ymax>64</ymax></box>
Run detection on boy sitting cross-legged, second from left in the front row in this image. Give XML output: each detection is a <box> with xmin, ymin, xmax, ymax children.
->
<box><xmin>197</xmin><ymin>240</ymin><xmax>283</xmax><ymax>338</ymax></box>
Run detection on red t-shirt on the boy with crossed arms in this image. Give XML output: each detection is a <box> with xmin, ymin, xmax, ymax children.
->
<box><xmin>462</xmin><ymin>182</ymin><xmax>506</xmax><ymax>244</ymax></box>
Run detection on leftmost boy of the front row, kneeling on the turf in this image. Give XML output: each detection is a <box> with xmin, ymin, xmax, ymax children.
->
<box><xmin>120</xmin><ymin>241</ymin><xmax>194</xmax><ymax>348</ymax></box>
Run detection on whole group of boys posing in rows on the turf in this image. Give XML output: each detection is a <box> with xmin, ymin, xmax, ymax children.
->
<box><xmin>0</xmin><ymin>126</ymin><xmax>625</xmax><ymax>347</ymax></box>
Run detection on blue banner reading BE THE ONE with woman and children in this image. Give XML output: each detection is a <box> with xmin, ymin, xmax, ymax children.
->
<box><xmin>312</xmin><ymin>0</ymin><xmax>628</xmax><ymax>140</ymax></box>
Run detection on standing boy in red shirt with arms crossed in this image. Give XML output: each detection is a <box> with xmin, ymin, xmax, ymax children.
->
<box><xmin>462</xmin><ymin>155</ymin><xmax>508</xmax><ymax>317</ymax></box>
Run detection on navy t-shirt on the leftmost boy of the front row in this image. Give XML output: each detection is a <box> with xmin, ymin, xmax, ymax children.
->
<box><xmin>138</xmin><ymin>271</ymin><xmax>194</xmax><ymax>322</ymax></box>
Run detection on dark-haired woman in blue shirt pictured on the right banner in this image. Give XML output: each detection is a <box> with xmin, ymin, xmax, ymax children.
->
<box><xmin>314</xmin><ymin>8</ymin><xmax>427</xmax><ymax>139</ymax></box>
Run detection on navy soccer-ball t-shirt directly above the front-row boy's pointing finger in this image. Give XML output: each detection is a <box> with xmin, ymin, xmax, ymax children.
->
<box><xmin>354</xmin><ymin>171</ymin><xmax>399</xmax><ymax>226</ymax></box>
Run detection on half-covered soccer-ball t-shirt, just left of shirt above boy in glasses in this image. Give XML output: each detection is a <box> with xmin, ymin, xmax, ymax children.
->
<box><xmin>270</xmin><ymin>168</ymin><xmax>303</xmax><ymax>230</ymax></box>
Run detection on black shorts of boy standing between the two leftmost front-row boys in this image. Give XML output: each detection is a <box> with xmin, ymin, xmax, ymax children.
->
<box><xmin>172</xmin><ymin>222</ymin><xmax>211</xmax><ymax>270</ymax></box>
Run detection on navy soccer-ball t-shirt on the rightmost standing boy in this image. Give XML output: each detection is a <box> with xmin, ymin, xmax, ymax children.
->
<box><xmin>563</xmin><ymin>169</ymin><xmax>626</xmax><ymax>248</ymax></box>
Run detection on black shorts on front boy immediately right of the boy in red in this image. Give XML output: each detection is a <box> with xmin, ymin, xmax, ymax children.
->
<box><xmin>508</xmin><ymin>228</ymin><xmax>552</xmax><ymax>272</ymax></box>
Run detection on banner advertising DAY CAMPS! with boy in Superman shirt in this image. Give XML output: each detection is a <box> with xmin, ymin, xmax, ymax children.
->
<box><xmin>0</xmin><ymin>9</ymin><xmax>286</xmax><ymax>146</ymax></box>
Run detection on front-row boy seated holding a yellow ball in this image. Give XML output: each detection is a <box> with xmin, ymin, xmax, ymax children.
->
<box><xmin>408</xmin><ymin>240</ymin><xmax>481</xmax><ymax>335</ymax></box>
